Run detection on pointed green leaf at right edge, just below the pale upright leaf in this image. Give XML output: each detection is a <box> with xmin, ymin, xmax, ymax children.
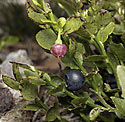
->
<box><xmin>111</xmin><ymin>97</ymin><xmax>125</xmax><ymax>116</ymax></box>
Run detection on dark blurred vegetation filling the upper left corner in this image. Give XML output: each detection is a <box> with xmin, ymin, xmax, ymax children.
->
<box><xmin>0</xmin><ymin>0</ymin><xmax>38</xmax><ymax>41</ymax></box>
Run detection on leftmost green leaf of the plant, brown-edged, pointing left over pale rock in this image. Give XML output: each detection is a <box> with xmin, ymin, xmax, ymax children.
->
<box><xmin>2</xmin><ymin>76</ymin><xmax>19</xmax><ymax>90</ymax></box>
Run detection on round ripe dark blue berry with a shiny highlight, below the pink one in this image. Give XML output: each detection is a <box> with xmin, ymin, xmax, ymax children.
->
<box><xmin>65</xmin><ymin>69</ymin><xmax>85</xmax><ymax>91</ymax></box>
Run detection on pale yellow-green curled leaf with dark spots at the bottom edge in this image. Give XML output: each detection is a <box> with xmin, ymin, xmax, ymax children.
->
<box><xmin>89</xmin><ymin>107</ymin><xmax>103</xmax><ymax>121</ymax></box>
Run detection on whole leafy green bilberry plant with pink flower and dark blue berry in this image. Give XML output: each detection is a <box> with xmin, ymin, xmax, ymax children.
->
<box><xmin>3</xmin><ymin>0</ymin><xmax>125</xmax><ymax>122</ymax></box>
